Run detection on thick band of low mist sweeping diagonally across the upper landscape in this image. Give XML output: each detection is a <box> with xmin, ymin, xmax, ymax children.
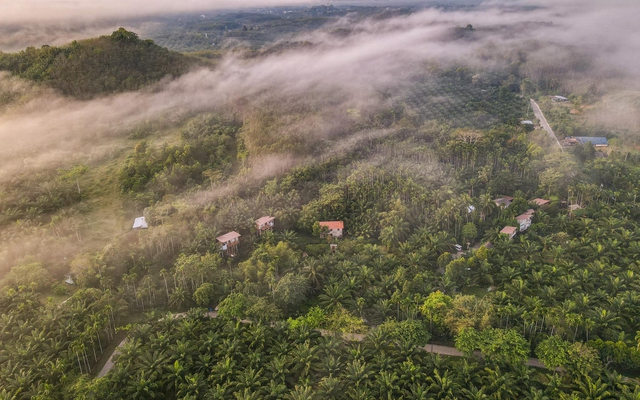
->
<box><xmin>0</xmin><ymin>0</ymin><xmax>640</xmax><ymax>179</ymax></box>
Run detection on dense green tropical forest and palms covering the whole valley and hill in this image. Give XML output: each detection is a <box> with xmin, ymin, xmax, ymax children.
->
<box><xmin>0</xmin><ymin>1</ymin><xmax>640</xmax><ymax>400</ymax></box>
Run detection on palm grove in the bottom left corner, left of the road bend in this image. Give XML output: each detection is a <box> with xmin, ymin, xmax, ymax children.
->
<box><xmin>0</xmin><ymin>288</ymin><xmax>127</xmax><ymax>399</ymax></box>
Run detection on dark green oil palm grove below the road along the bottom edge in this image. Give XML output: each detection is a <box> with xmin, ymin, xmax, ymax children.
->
<box><xmin>76</xmin><ymin>313</ymin><xmax>633</xmax><ymax>400</ymax></box>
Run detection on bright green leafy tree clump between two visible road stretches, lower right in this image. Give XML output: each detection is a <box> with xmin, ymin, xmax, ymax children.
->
<box><xmin>456</xmin><ymin>328</ymin><xmax>529</xmax><ymax>364</ymax></box>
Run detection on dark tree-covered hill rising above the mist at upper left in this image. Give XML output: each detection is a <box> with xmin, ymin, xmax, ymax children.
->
<box><xmin>0</xmin><ymin>28</ymin><xmax>196</xmax><ymax>99</ymax></box>
